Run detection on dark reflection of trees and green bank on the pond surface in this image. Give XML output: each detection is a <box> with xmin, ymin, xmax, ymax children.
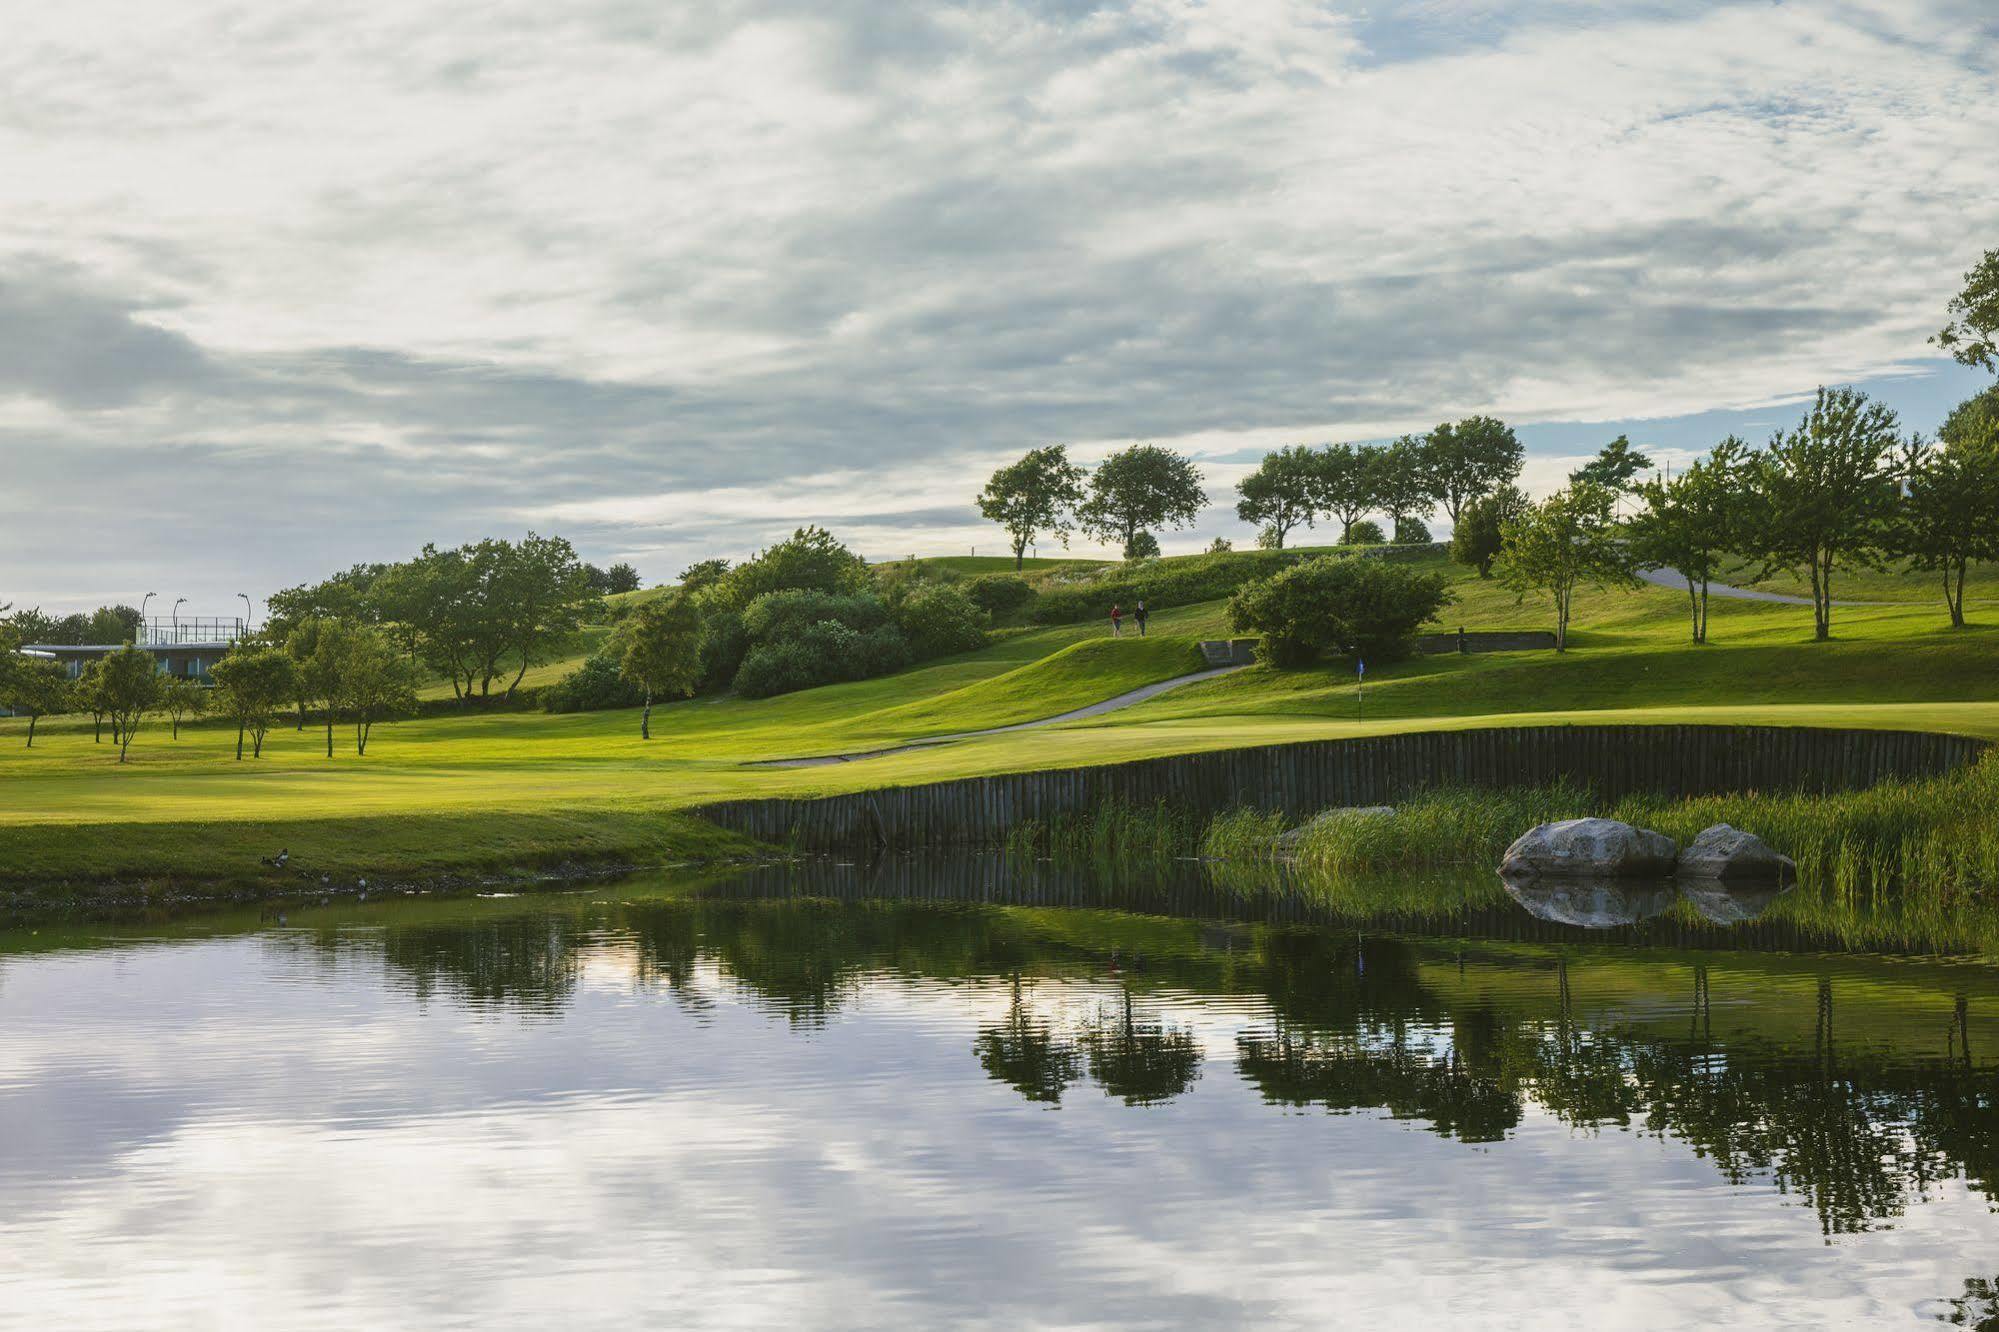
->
<box><xmin>272</xmin><ymin>860</ymin><xmax>1999</xmax><ymax>1236</ymax></box>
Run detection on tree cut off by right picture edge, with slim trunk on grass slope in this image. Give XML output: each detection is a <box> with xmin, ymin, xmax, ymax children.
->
<box><xmin>1895</xmin><ymin>388</ymin><xmax>1999</xmax><ymax>628</ymax></box>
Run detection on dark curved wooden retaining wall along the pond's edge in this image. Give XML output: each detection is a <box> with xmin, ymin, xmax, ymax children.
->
<box><xmin>690</xmin><ymin>726</ymin><xmax>1985</xmax><ymax>850</ymax></box>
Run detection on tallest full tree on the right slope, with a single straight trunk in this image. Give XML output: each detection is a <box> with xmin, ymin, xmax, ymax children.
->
<box><xmin>1745</xmin><ymin>388</ymin><xmax>1897</xmax><ymax>642</ymax></box>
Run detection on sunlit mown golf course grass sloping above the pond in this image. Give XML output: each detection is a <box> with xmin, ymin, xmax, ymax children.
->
<box><xmin>0</xmin><ymin>544</ymin><xmax>1999</xmax><ymax>878</ymax></box>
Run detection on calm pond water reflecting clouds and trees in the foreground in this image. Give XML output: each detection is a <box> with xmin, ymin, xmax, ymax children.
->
<box><xmin>0</xmin><ymin>860</ymin><xmax>1999</xmax><ymax>1328</ymax></box>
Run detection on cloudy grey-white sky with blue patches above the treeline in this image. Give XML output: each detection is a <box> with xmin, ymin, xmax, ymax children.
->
<box><xmin>0</xmin><ymin>0</ymin><xmax>1999</xmax><ymax>614</ymax></box>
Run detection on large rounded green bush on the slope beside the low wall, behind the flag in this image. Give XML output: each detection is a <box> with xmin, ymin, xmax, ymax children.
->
<box><xmin>1229</xmin><ymin>556</ymin><xmax>1451</xmax><ymax>666</ymax></box>
